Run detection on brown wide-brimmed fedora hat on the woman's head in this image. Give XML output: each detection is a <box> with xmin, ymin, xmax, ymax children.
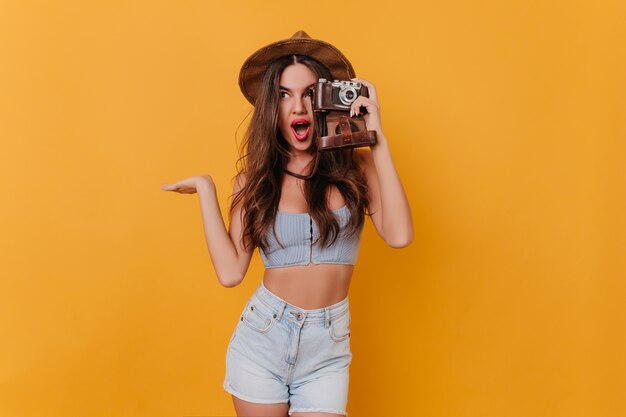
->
<box><xmin>239</xmin><ymin>30</ymin><xmax>355</xmax><ymax>105</ymax></box>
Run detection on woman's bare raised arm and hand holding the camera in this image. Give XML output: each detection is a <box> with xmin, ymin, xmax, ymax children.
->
<box><xmin>352</xmin><ymin>79</ymin><xmax>413</xmax><ymax>248</ymax></box>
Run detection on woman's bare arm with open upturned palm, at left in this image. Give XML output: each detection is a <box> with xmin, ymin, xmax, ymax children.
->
<box><xmin>162</xmin><ymin>175</ymin><xmax>252</xmax><ymax>287</ymax></box>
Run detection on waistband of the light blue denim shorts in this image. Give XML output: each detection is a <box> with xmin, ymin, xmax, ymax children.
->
<box><xmin>254</xmin><ymin>281</ymin><xmax>349</xmax><ymax>324</ymax></box>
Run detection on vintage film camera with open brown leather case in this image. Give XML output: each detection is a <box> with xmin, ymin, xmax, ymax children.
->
<box><xmin>313</xmin><ymin>78</ymin><xmax>376</xmax><ymax>151</ymax></box>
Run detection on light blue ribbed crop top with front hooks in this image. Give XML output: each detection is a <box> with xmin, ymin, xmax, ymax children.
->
<box><xmin>259</xmin><ymin>206</ymin><xmax>363</xmax><ymax>268</ymax></box>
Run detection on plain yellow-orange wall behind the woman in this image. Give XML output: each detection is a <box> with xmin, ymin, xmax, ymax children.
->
<box><xmin>0</xmin><ymin>0</ymin><xmax>626</xmax><ymax>417</ymax></box>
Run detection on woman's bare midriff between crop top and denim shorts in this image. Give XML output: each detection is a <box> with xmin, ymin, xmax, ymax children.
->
<box><xmin>263</xmin><ymin>264</ymin><xmax>354</xmax><ymax>310</ymax></box>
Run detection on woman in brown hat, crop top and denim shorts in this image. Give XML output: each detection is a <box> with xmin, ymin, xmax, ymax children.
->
<box><xmin>162</xmin><ymin>31</ymin><xmax>413</xmax><ymax>417</ymax></box>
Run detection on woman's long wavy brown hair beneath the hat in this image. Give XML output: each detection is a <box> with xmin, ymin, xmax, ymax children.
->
<box><xmin>230</xmin><ymin>55</ymin><xmax>369</xmax><ymax>250</ymax></box>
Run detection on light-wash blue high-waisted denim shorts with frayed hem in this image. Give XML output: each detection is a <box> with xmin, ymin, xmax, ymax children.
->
<box><xmin>224</xmin><ymin>282</ymin><xmax>352</xmax><ymax>415</ymax></box>
